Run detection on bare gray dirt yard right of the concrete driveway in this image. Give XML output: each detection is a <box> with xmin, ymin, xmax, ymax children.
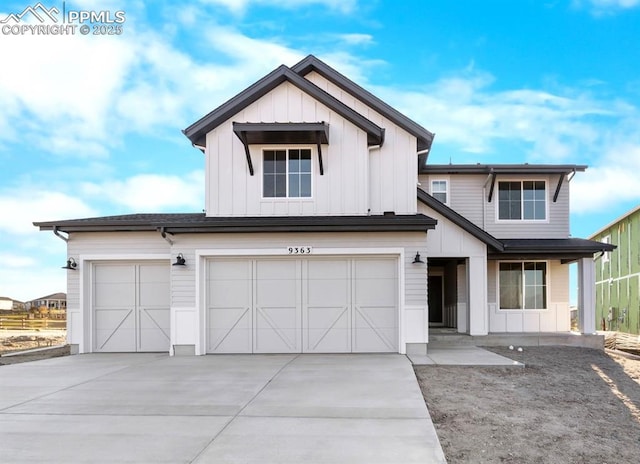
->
<box><xmin>415</xmin><ymin>347</ymin><xmax>640</xmax><ymax>464</ymax></box>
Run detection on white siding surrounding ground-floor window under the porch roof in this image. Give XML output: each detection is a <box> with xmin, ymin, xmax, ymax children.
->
<box><xmin>487</xmin><ymin>261</ymin><xmax>571</xmax><ymax>333</ymax></box>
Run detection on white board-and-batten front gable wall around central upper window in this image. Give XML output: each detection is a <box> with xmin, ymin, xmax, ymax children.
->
<box><xmin>206</xmin><ymin>83</ymin><xmax>376</xmax><ymax>216</ymax></box>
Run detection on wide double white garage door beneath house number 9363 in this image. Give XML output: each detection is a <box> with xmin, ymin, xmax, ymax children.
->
<box><xmin>207</xmin><ymin>258</ymin><xmax>398</xmax><ymax>353</ymax></box>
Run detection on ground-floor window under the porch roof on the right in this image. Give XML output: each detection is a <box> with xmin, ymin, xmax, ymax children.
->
<box><xmin>499</xmin><ymin>261</ymin><xmax>547</xmax><ymax>309</ymax></box>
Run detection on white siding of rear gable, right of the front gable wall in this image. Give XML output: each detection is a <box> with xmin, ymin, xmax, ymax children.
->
<box><xmin>305</xmin><ymin>71</ymin><xmax>418</xmax><ymax>214</ymax></box>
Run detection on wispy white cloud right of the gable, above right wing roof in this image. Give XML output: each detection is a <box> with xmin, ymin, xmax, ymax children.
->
<box><xmin>374</xmin><ymin>72</ymin><xmax>638</xmax><ymax>162</ymax></box>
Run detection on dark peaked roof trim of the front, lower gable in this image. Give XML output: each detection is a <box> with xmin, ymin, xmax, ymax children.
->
<box><xmin>182</xmin><ymin>65</ymin><xmax>384</xmax><ymax>146</ymax></box>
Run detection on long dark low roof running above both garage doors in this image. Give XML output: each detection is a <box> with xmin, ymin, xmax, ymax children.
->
<box><xmin>34</xmin><ymin>213</ymin><xmax>437</xmax><ymax>234</ymax></box>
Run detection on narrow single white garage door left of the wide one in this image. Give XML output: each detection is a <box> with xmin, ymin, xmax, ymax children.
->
<box><xmin>92</xmin><ymin>263</ymin><xmax>170</xmax><ymax>352</ymax></box>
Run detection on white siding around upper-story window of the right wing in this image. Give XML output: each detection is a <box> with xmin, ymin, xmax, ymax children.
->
<box><xmin>419</xmin><ymin>174</ymin><xmax>569</xmax><ymax>238</ymax></box>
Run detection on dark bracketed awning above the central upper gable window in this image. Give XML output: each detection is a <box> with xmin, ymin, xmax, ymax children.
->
<box><xmin>233</xmin><ymin>121</ymin><xmax>329</xmax><ymax>176</ymax></box>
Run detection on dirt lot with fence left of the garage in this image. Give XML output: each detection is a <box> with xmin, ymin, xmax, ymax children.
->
<box><xmin>0</xmin><ymin>330</ymin><xmax>69</xmax><ymax>366</ymax></box>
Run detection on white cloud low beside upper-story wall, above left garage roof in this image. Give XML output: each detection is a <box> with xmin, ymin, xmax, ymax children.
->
<box><xmin>80</xmin><ymin>171</ymin><xmax>204</xmax><ymax>212</ymax></box>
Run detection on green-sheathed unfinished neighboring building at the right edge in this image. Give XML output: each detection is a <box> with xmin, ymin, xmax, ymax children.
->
<box><xmin>591</xmin><ymin>206</ymin><xmax>640</xmax><ymax>335</ymax></box>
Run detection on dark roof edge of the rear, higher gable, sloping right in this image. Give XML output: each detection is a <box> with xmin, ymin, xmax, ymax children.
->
<box><xmin>291</xmin><ymin>55</ymin><xmax>435</xmax><ymax>151</ymax></box>
